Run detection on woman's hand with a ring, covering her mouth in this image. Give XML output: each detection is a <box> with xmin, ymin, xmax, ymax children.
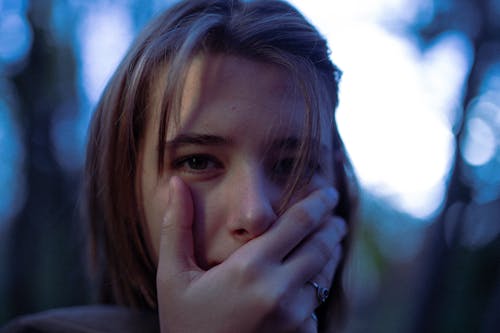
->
<box><xmin>157</xmin><ymin>177</ymin><xmax>346</xmax><ymax>332</ymax></box>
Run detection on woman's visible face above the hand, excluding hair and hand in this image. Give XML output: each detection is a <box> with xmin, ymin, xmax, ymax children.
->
<box><xmin>141</xmin><ymin>55</ymin><xmax>333</xmax><ymax>269</ymax></box>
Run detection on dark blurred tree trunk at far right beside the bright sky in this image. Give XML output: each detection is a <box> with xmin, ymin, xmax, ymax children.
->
<box><xmin>409</xmin><ymin>0</ymin><xmax>500</xmax><ymax>333</ymax></box>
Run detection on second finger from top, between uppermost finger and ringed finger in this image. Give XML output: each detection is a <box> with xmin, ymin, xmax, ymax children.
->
<box><xmin>283</xmin><ymin>217</ymin><xmax>347</xmax><ymax>286</ymax></box>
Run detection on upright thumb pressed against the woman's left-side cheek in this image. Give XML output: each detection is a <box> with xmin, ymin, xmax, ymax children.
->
<box><xmin>157</xmin><ymin>176</ymin><xmax>200</xmax><ymax>284</ymax></box>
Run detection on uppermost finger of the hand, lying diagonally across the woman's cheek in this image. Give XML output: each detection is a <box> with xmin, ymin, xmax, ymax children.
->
<box><xmin>255</xmin><ymin>188</ymin><xmax>338</xmax><ymax>261</ymax></box>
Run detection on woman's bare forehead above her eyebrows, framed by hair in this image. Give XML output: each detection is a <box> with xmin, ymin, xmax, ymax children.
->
<box><xmin>149</xmin><ymin>54</ymin><xmax>336</xmax><ymax>143</ymax></box>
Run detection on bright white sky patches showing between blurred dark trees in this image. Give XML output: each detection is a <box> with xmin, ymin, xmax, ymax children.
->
<box><xmin>80</xmin><ymin>0</ymin><xmax>472</xmax><ymax>220</ymax></box>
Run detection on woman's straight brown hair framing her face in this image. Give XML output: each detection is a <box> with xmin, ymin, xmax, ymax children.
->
<box><xmin>85</xmin><ymin>0</ymin><xmax>355</xmax><ymax>329</ymax></box>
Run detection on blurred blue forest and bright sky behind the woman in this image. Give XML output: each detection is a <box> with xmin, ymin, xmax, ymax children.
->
<box><xmin>0</xmin><ymin>0</ymin><xmax>500</xmax><ymax>333</ymax></box>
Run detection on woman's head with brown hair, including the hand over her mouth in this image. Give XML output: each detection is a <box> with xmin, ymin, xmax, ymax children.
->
<box><xmin>2</xmin><ymin>0</ymin><xmax>354</xmax><ymax>332</ymax></box>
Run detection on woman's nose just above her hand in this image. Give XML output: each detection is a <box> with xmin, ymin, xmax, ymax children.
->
<box><xmin>229</xmin><ymin>167</ymin><xmax>279</xmax><ymax>242</ymax></box>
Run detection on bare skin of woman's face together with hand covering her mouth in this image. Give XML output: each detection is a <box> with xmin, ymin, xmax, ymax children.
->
<box><xmin>141</xmin><ymin>55</ymin><xmax>346</xmax><ymax>332</ymax></box>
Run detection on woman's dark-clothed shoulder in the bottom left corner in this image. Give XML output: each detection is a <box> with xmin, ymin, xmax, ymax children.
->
<box><xmin>0</xmin><ymin>305</ymin><xmax>160</xmax><ymax>333</ymax></box>
